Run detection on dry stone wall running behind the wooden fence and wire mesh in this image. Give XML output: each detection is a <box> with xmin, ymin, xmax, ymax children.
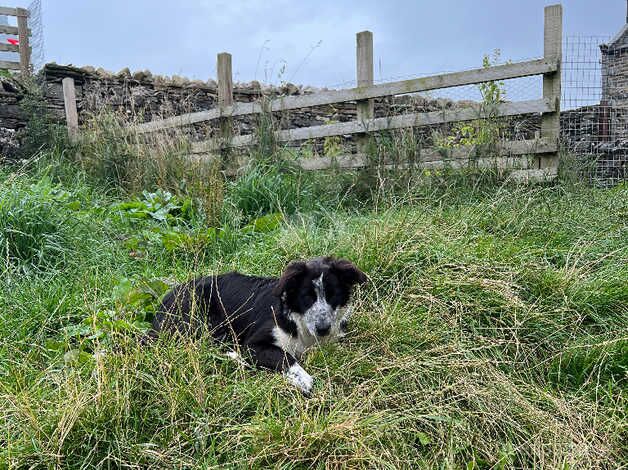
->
<box><xmin>0</xmin><ymin>64</ymin><xmax>628</xmax><ymax>185</ymax></box>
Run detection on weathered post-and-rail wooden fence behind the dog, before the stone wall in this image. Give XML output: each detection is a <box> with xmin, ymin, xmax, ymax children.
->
<box><xmin>64</xmin><ymin>5</ymin><xmax>562</xmax><ymax>179</ymax></box>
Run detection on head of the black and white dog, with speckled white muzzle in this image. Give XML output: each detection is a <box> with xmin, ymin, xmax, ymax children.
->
<box><xmin>273</xmin><ymin>257</ymin><xmax>366</xmax><ymax>337</ymax></box>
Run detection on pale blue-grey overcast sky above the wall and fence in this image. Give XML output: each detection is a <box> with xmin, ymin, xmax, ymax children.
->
<box><xmin>0</xmin><ymin>0</ymin><xmax>626</xmax><ymax>86</ymax></box>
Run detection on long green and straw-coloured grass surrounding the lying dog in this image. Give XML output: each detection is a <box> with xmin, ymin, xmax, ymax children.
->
<box><xmin>0</xmin><ymin>156</ymin><xmax>628</xmax><ymax>469</ymax></box>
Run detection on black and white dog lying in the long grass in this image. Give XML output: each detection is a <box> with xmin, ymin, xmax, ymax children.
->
<box><xmin>151</xmin><ymin>257</ymin><xmax>366</xmax><ymax>394</ymax></box>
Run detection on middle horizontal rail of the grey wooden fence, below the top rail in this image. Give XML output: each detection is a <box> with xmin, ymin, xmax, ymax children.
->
<box><xmin>192</xmin><ymin>99</ymin><xmax>554</xmax><ymax>153</ymax></box>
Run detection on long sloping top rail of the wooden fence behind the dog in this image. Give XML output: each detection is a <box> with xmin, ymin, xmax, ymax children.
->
<box><xmin>130</xmin><ymin>59</ymin><xmax>558</xmax><ymax>133</ymax></box>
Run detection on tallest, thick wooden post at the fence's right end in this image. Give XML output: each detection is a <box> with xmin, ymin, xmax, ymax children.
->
<box><xmin>539</xmin><ymin>4</ymin><xmax>563</xmax><ymax>170</ymax></box>
